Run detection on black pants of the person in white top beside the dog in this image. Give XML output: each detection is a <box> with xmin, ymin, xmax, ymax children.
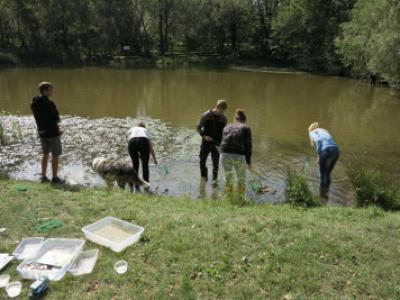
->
<box><xmin>128</xmin><ymin>137</ymin><xmax>150</xmax><ymax>182</ymax></box>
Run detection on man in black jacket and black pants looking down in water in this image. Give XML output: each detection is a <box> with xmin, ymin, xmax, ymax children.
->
<box><xmin>197</xmin><ymin>100</ymin><xmax>228</xmax><ymax>181</ymax></box>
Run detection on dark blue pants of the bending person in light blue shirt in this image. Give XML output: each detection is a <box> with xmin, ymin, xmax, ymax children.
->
<box><xmin>319</xmin><ymin>147</ymin><xmax>340</xmax><ymax>197</ymax></box>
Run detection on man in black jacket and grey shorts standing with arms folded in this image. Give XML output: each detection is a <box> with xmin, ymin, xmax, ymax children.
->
<box><xmin>31</xmin><ymin>82</ymin><xmax>64</xmax><ymax>184</ymax></box>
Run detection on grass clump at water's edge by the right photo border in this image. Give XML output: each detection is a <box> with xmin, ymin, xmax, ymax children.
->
<box><xmin>349</xmin><ymin>168</ymin><xmax>400</xmax><ymax>210</ymax></box>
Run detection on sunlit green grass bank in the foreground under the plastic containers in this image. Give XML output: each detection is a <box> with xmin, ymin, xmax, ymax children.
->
<box><xmin>0</xmin><ymin>180</ymin><xmax>400</xmax><ymax>300</ymax></box>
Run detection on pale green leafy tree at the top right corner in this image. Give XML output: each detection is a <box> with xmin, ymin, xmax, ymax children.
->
<box><xmin>336</xmin><ymin>0</ymin><xmax>400</xmax><ymax>86</ymax></box>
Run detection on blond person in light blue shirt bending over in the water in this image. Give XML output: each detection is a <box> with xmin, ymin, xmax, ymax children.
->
<box><xmin>308</xmin><ymin>122</ymin><xmax>340</xmax><ymax>198</ymax></box>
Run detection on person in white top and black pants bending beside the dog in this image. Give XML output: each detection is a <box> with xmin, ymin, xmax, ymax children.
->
<box><xmin>128</xmin><ymin>123</ymin><xmax>158</xmax><ymax>190</ymax></box>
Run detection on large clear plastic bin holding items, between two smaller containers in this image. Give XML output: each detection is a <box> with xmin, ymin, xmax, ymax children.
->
<box><xmin>17</xmin><ymin>239</ymin><xmax>85</xmax><ymax>281</ymax></box>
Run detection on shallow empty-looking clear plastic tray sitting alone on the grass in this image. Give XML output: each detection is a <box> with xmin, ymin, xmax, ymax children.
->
<box><xmin>82</xmin><ymin>217</ymin><xmax>144</xmax><ymax>252</ymax></box>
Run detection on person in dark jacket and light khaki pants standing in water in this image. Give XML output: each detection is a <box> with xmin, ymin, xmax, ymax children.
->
<box><xmin>221</xmin><ymin>109</ymin><xmax>252</xmax><ymax>200</ymax></box>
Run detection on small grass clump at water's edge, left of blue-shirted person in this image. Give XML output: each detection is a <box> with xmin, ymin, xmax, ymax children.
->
<box><xmin>286</xmin><ymin>169</ymin><xmax>319</xmax><ymax>207</ymax></box>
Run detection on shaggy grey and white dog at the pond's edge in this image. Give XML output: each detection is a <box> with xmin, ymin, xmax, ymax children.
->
<box><xmin>92</xmin><ymin>157</ymin><xmax>150</xmax><ymax>192</ymax></box>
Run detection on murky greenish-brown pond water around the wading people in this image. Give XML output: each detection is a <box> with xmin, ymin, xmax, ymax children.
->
<box><xmin>0</xmin><ymin>68</ymin><xmax>400</xmax><ymax>205</ymax></box>
